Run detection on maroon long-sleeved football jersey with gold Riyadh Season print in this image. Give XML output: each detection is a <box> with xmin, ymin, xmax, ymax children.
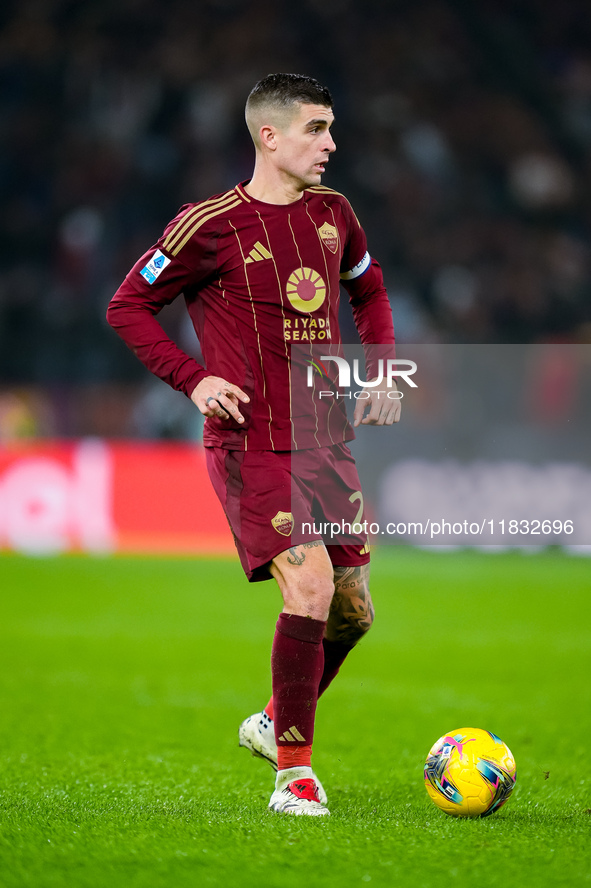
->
<box><xmin>108</xmin><ymin>185</ymin><xmax>394</xmax><ymax>450</ymax></box>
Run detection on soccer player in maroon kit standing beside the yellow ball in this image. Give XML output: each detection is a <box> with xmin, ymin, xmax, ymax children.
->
<box><xmin>107</xmin><ymin>74</ymin><xmax>400</xmax><ymax>816</ymax></box>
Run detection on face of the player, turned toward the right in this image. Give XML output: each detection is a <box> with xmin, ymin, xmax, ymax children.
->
<box><xmin>275</xmin><ymin>105</ymin><xmax>336</xmax><ymax>190</ymax></box>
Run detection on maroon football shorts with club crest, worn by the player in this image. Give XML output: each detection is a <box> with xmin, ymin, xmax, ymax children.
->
<box><xmin>205</xmin><ymin>444</ymin><xmax>369</xmax><ymax>582</ymax></box>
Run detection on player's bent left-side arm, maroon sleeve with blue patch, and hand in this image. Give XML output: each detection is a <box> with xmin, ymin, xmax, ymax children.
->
<box><xmin>107</xmin><ymin>247</ymin><xmax>249</xmax><ymax>422</ymax></box>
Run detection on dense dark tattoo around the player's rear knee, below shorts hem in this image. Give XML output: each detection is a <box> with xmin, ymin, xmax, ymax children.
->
<box><xmin>326</xmin><ymin>565</ymin><xmax>374</xmax><ymax>645</ymax></box>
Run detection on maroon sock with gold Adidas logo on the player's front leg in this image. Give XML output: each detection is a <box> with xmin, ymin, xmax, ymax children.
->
<box><xmin>271</xmin><ymin>614</ymin><xmax>326</xmax><ymax>770</ymax></box>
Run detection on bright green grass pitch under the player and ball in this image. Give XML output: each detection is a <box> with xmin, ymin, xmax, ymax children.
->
<box><xmin>0</xmin><ymin>548</ymin><xmax>591</xmax><ymax>888</ymax></box>
